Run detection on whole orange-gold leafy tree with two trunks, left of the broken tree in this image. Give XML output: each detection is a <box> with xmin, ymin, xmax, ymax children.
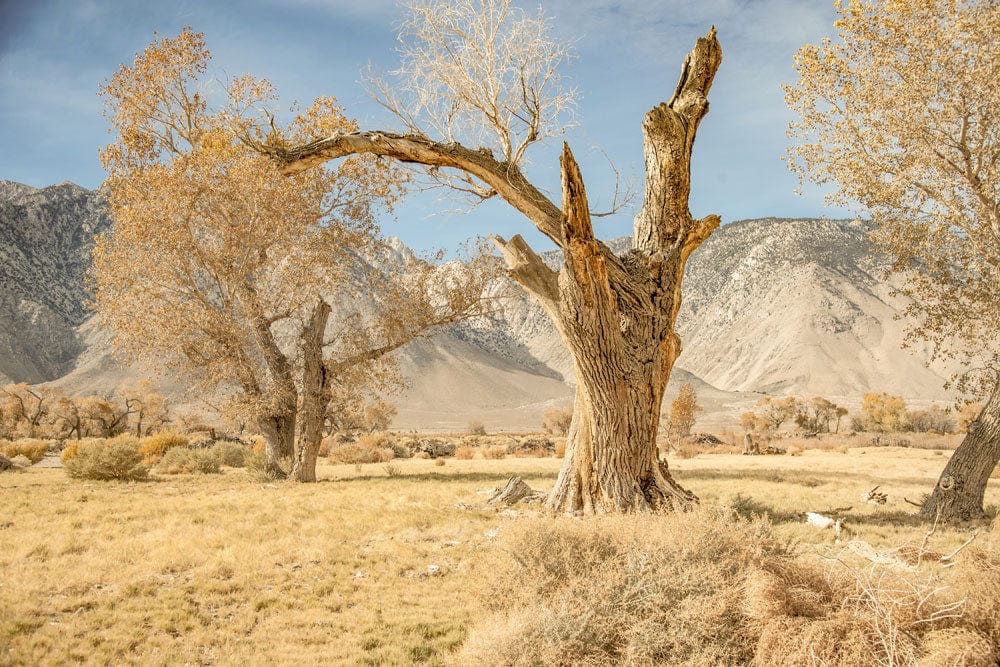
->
<box><xmin>93</xmin><ymin>29</ymin><xmax>494</xmax><ymax>481</ymax></box>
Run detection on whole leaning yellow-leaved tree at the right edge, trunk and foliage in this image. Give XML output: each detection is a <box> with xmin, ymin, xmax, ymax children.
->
<box><xmin>786</xmin><ymin>0</ymin><xmax>1000</xmax><ymax>518</ymax></box>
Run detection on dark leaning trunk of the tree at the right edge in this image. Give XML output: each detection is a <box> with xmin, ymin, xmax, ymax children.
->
<box><xmin>920</xmin><ymin>382</ymin><xmax>1000</xmax><ymax>520</ymax></box>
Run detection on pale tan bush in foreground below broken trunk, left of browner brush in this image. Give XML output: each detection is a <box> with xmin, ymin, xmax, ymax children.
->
<box><xmin>460</xmin><ymin>510</ymin><xmax>786</xmax><ymax>665</ymax></box>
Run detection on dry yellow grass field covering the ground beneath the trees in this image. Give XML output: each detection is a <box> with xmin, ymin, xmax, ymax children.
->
<box><xmin>0</xmin><ymin>447</ymin><xmax>1000</xmax><ymax>665</ymax></box>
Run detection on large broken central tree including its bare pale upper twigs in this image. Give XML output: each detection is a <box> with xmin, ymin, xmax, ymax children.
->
<box><xmin>261</xmin><ymin>0</ymin><xmax>722</xmax><ymax>514</ymax></box>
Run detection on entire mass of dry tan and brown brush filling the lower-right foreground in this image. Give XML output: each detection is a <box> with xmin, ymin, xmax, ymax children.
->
<box><xmin>459</xmin><ymin>508</ymin><xmax>1000</xmax><ymax>666</ymax></box>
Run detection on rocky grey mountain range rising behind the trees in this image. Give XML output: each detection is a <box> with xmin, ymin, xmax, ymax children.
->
<box><xmin>0</xmin><ymin>181</ymin><xmax>954</xmax><ymax>429</ymax></box>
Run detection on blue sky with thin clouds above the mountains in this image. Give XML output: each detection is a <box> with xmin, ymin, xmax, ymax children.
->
<box><xmin>0</xmin><ymin>0</ymin><xmax>844</xmax><ymax>249</ymax></box>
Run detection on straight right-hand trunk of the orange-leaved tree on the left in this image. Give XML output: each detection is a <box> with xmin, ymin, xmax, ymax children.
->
<box><xmin>290</xmin><ymin>301</ymin><xmax>330</xmax><ymax>482</ymax></box>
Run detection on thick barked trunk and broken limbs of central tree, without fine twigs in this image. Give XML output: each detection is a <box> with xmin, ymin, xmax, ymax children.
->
<box><xmin>278</xmin><ymin>28</ymin><xmax>722</xmax><ymax>513</ymax></box>
